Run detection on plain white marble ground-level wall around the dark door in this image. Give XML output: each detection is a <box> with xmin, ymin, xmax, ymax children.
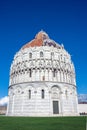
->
<box><xmin>7</xmin><ymin>82</ymin><xmax>78</xmax><ymax>116</ymax></box>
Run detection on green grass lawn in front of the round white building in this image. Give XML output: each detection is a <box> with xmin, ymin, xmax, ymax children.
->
<box><xmin>0</xmin><ymin>116</ymin><xmax>86</xmax><ymax>130</ymax></box>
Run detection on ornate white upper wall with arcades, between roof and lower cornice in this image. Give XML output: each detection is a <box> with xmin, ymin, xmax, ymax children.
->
<box><xmin>9</xmin><ymin>46</ymin><xmax>76</xmax><ymax>85</ymax></box>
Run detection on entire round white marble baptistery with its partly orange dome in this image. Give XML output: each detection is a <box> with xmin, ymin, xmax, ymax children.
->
<box><xmin>7</xmin><ymin>31</ymin><xmax>78</xmax><ymax>116</ymax></box>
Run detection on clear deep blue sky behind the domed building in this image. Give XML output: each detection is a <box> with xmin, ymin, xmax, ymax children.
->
<box><xmin>0</xmin><ymin>0</ymin><xmax>87</xmax><ymax>98</ymax></box>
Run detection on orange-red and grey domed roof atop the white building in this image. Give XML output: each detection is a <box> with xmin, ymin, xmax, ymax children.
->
<box><xmin>22</xmin><ymin>31</ymin><xmax>60</xmax><ymax>49</ymax></box>
